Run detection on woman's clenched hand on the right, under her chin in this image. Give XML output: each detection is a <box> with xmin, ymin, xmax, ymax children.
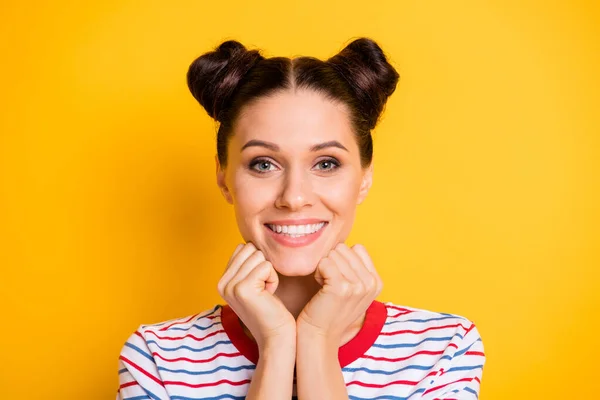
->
<box><xmin>297</xmin><ymin>243</ymin><xmax>383</xmax><ymax>345</ymax></box>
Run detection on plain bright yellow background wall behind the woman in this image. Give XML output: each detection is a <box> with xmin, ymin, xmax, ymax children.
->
<box><xmin>0</xmin><ymin>0</ymin><xmax>600</xmax><ymax>400</ymax></box>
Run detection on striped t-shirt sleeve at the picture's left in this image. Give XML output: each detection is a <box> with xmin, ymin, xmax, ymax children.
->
<box><xmin>116</xmin><ymin>329</ymin><xmax>169</xmax><ymax>400</ymax></box>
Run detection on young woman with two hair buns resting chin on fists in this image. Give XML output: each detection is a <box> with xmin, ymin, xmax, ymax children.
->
<box><xmin>117</xmin><ymin>38</ymin><xmax>485</xmax><ymax>400</ymax></box>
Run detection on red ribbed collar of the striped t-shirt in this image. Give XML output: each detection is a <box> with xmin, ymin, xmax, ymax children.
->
<box><xmin>221</xmin><ymin>300</ymin><xmax>387</xmax><ymax>368</ymax></box>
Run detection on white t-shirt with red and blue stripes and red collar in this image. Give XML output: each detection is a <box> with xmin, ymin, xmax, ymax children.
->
<box><xmin>117</xmin><ymin>301</ymin><xmax>485</xmax><ymax>400</ymax></box>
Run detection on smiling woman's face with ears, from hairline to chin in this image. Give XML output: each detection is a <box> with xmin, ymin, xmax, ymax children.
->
<box><xmin>217</xmin><ymin>90</ymin><xmax>372</xmax><ymax>276</ymax></box>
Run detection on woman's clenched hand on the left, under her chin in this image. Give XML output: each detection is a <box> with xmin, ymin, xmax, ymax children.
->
<box><xmin>217</xmin><ymin>243</ymin><xmax>296</xmax><ymax>349</ymax></box>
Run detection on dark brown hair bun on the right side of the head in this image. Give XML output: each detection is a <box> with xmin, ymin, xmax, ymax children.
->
<box><xmin>327</xmin><ymin>38</ymin><xmax>400</xmax><ymax>129</ymax></box>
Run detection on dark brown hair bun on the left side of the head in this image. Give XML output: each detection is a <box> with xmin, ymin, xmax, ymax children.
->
<box><xmin>187</xmin><ymin>40</ymin><xmax>264</xmax><ymax>121</ymax></box>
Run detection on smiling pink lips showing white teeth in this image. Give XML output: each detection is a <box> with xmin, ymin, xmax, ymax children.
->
<box><xmin>265</xmin><ymin>219</ymin><xmax>328</xmax><ymax>247</ymax></box>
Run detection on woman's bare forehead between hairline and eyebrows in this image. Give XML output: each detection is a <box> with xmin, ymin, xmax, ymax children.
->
<box><xmin>232</xmin><ymin>89</ymin><xmax>354</xmax><ymax>150</ymax></box>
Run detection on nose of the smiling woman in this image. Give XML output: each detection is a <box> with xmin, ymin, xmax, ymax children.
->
<box><xmin>275</xmin><ymin>168</ymin><xmax>314</xmax><ymax>211</ymax></box>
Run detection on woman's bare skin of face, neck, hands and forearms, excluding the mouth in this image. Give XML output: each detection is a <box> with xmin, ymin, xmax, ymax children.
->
<box><xmin>216</xmin><ymin>90</ymin><xmax>382</xmax><ymax>399</ymax></box>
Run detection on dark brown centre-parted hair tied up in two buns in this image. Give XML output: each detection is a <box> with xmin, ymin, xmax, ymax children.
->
<box><xmin>187</xmin><ymin>38</ymin><xmax>399</xmax><ymax>167</ymax></box>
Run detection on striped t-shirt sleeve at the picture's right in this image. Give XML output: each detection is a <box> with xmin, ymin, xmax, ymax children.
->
<box><xmin>423</xmin><ymin>322</ymin><xmax>485</xmax><ymax>400</ymax></box>
